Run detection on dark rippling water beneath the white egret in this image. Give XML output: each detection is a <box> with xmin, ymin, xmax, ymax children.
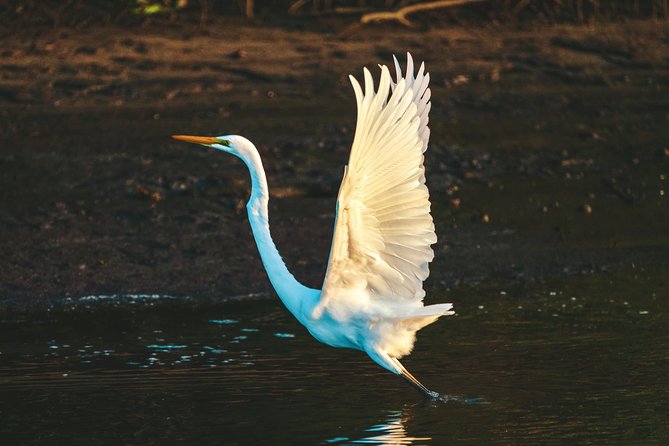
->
<box><xmin>0</xmin><ymin>268</ymin><xmax>669</xmax><ymax>445</ymax></box>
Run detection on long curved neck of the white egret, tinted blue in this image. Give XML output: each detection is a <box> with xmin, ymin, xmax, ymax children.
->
<box><xmin>237</xmin><ymin>138</ymin><xmax>319</xmax><ymax>319</ymax></box>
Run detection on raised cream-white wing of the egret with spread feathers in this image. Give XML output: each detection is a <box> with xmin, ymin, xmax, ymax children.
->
<box><xmin>320</xmin><ymin>54</ymin><xmax>437</xmax><ymax>308</ymax></box>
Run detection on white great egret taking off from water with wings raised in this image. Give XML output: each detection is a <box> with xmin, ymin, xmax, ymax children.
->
<box><xmin>173</xmin><ymin>53</ymin><xmax>453</xmax><ymax>399</ymax></box>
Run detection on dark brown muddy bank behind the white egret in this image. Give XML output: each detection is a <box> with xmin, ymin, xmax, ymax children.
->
<box><xmin>0</xmin><ymin>21</ymin><xmax>669</xmax><ymax>302</ymax></box>
